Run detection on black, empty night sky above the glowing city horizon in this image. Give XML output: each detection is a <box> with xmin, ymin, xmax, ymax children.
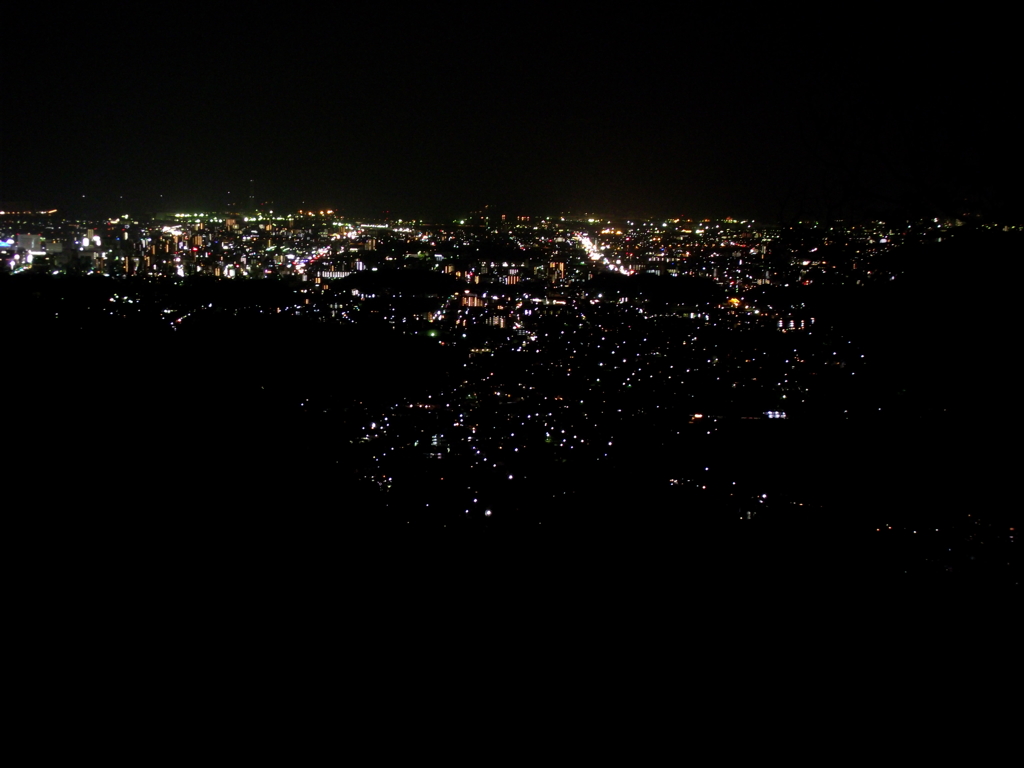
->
<box><xmin>0</xmin><ymin>11</ymin><xmax>1020</xmax><ymax>219</ymax></box>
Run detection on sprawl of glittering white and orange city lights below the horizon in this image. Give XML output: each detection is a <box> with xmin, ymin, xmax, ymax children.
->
<box><xmin>0</xmin><ymin>211</ymin><xmax>1007</xmax><ymax>544</ymax></box>
